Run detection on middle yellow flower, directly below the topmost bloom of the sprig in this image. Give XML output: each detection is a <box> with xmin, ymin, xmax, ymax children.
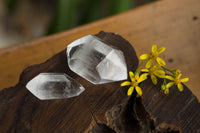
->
<box><xmin>141</xmin><ymin>64</ymin><xmax>165</xmax><ymax>85</ymax></box>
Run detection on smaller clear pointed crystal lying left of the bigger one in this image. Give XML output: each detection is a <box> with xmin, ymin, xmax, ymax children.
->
<box><xmin>26</xmin><ymin>73</ymin><xmax>85</xmax><ymax>100</ymax></box>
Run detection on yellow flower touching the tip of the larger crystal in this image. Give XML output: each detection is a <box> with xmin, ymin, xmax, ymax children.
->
<box><xmin>121</xmin><ymin>71</ymin><xmax>148</xmax><ymax>96</ymax></box>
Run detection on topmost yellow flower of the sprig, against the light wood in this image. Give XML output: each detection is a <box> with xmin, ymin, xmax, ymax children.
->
<box><xmin>140</xmin><ymin>45</ymin><xmax>165</xmax><ymax>68</ymax></box>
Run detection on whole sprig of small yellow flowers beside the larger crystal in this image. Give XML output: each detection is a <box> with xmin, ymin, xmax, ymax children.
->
<box><xmin>121</xmin><ymin>45</ymin><xmax>189</xmax><ymax>96</ymax></box>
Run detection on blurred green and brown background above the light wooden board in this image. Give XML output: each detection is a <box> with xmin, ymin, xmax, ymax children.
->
<box><xmin>0</xmin><ymin>0</ymin><xmax>155</xmax><ymax>48</ymax></box>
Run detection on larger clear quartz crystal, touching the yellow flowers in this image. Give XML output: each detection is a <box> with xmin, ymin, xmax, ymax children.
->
<box><xmin>67</xmin><ymin>35</ymin><xmax>127</xmax><ymax>84</ymax></box>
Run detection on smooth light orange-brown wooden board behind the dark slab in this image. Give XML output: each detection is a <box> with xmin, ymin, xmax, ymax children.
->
<box><xmin>0</xmin><ymin>0</ymin><xmax>200</xmax><ymax>99</ymax></box>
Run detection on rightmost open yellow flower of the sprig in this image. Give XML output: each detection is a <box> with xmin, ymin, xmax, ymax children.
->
<box><xmin>165</xmin><ymin>74</ymin><xmax>189</xmax><ymax>91</ymax></box>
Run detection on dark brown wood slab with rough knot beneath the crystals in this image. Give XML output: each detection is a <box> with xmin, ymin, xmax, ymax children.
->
<box><xmin>0</xmin><ymin>32</ymin><xmax>200</xmax><ymax>133</ymax></box>
